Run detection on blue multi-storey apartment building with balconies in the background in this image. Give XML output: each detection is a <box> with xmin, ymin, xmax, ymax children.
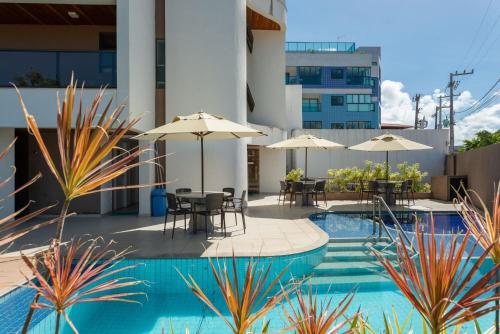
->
<box><xmin>285</xmin><ymin>42</ymin><xmax>381</xmax><ymax>129</ymax></box>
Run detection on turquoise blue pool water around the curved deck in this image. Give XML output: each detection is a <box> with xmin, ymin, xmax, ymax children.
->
<box><xmin>0</xmin><ymin>213</ymin><xmax>493</xmax><ymax>334</ymax></box>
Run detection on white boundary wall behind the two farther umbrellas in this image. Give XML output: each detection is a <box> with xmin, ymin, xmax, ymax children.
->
<box><xmin>293</xmin><ymin>129</ymin><xmax>448</xmax><ymax>182</ymax></box>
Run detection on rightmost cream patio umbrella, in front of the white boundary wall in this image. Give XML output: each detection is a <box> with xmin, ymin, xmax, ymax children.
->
<box><xmin>349</xmin><ymin>133</ymin><xmax>432</xmax><ymax>181</ymax></box>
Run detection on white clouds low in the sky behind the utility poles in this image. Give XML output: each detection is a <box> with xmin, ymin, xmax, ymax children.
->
<box><xmin>381</xmin><ymin>80</ymin><xmax>500</xmax><ymax>145</ymax></box>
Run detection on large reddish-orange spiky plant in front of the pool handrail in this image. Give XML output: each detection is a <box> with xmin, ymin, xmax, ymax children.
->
<box><xmin>374</xmin><ymin>218</ymin><xmax>500</xmax><ymax>334</ymax></box>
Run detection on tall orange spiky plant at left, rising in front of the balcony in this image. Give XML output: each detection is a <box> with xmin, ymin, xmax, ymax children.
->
<box><xmin>16</xmin><ymin>76</ymin><xmax>157</xmax><ymax>242</ymax></box>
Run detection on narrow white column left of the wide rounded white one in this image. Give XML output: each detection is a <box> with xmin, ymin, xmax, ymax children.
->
<box><xmin>116</xmin><ymin>0</ymin><xmax>156</xmax><ymax>215</ymax></box>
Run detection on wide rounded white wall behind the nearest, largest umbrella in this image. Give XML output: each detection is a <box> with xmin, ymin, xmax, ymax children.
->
<box><xmin>165</xmin><ymin>0</ymin><xmax>247</xmax><ymax>192</ymax></box>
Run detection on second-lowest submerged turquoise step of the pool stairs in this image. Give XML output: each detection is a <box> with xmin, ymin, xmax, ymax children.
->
<box><xmin>313</xmin><ymin>261</ymin><xmax>384</xmax><ymax>276</ymax></box>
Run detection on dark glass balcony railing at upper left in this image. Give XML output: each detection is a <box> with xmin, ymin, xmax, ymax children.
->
<box><xmin>0</xmin><ymin>50</ymin><xmax>116</xmax><ymax>88</ymax></box>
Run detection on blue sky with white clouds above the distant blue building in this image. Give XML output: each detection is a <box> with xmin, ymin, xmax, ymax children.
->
<box><xmin>286</xmin><ymin>0</ymin><xmax>500</xmax><ymax>143</ymax></box>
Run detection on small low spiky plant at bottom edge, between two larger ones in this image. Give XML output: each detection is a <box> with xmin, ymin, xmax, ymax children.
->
<box><xmin>282</xmin><ymin>285</ymin><xmax>356</xmax><ymax>334</ymax></box>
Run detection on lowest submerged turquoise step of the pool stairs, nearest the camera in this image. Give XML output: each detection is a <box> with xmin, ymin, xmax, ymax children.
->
<box><xmin>310</xmin><ymin>273</ymin><xmax>394</xmax><ymax>292</ymax></box>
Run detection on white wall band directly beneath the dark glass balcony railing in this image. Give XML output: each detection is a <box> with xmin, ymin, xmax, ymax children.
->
<box><xmin>0</xmin><ymin>88</ymin><xmax>116</xmax><ymax>128</ymax></box>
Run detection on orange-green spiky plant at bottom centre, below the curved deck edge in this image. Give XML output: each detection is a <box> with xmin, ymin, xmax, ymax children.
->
<box><xmin>177</xmin><ymin>252</ymin><xmax>288</xmax><ymax>334</ymax></box>
